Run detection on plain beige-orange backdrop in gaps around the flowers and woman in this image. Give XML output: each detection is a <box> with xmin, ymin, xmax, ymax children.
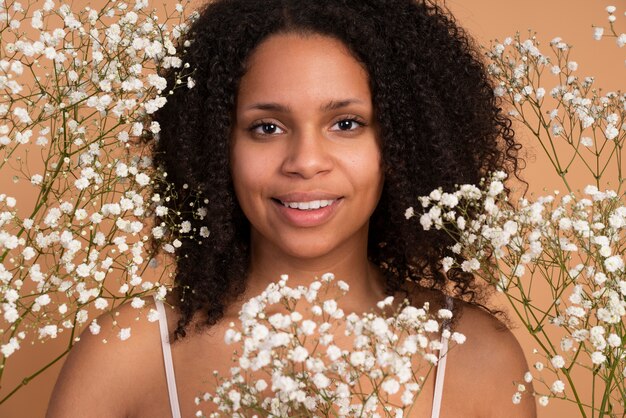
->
<box><xmin>0</xmin><ymin>0</ymin><xmax>626</xmax><ymax>418</ymax></box>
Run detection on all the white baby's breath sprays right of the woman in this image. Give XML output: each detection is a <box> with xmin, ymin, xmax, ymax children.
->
<box><xmin>405</xmin><ymin>6</ymin><xmax>626</xmax><ymax>417</ymax></box>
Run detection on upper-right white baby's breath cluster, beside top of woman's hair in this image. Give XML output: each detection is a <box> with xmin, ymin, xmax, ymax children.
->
<box><xmin>487</xmin><ymin>34</ymin><xmax>626</xmax><ymax>152</ymax></box>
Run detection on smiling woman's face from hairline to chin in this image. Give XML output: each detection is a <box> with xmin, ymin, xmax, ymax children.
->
<box><xmin>231</xmin><ymin>34</ymin><xmax>383</xmax><ymax>258</ymax></box>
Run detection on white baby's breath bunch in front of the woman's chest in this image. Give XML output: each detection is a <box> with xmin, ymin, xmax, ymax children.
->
<box><xmin>197</xmin><ymin>273</ymin><xmax>465</xmax><ymax>417</ymax></box>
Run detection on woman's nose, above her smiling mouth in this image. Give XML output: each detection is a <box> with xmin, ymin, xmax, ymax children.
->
<box><xmin>282</xmin><ymin>129</ymin><xmax>333</xmax><ymax>179</ymax></box>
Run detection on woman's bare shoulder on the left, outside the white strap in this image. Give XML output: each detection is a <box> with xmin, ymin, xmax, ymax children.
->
<box><xmin>46</xmin><ymin>297</ymin><xmax>161</xmax><ymax>418</ymax></box>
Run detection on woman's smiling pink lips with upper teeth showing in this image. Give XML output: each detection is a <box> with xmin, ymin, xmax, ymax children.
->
<box><xmin>272</xmin><ymin>193</ymin><xmax>342</xmax><ymax>228</ymax></box>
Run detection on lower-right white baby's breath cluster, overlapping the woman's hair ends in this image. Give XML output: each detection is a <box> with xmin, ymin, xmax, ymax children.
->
<box><xmin>412</xmin><ymin>173</ymin><xmax>626</xmax><ymax>412</ymax></box>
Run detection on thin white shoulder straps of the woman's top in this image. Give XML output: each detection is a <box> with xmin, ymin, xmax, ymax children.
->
<box><xmin>154</xmin><ymin>296</ymin><xmax>453</xmax><ymax>418</ymax></box>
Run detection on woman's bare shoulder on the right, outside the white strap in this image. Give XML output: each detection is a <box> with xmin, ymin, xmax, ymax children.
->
<box><xmin>446</xmin><ymin>301</ymin><xmax>536</xmax><ymax>418</ymax></box>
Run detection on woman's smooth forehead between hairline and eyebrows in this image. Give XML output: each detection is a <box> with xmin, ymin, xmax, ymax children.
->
<box><xmin>238</xmin><ymin>33</ymin><xmax>370</xmax><ymax>107</ymax></box>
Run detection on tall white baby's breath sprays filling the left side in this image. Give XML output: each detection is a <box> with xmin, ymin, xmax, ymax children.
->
<box><xmin>0</xmin><ymin>0</ymin><xmax>199</xmax><ymax>368</ymax></box>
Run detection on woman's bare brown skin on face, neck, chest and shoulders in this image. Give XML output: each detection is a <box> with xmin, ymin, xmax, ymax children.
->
<box><xmin>47</xmin><ymin>34</ymin><xmax>536</xmax><ymax>418</ymax></box>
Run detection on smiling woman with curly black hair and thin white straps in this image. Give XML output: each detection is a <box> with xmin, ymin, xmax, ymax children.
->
<box><xmin>48</xmin><ymin>0</ymin><xmax>535</xmax><ymax>417</ymax></box>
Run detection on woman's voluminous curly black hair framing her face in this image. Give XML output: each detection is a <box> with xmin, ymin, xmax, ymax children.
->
<box><xmin>146</xmin><ymin>0</ymin><xmax>522</xmax><ymax>338</ymax></box>
